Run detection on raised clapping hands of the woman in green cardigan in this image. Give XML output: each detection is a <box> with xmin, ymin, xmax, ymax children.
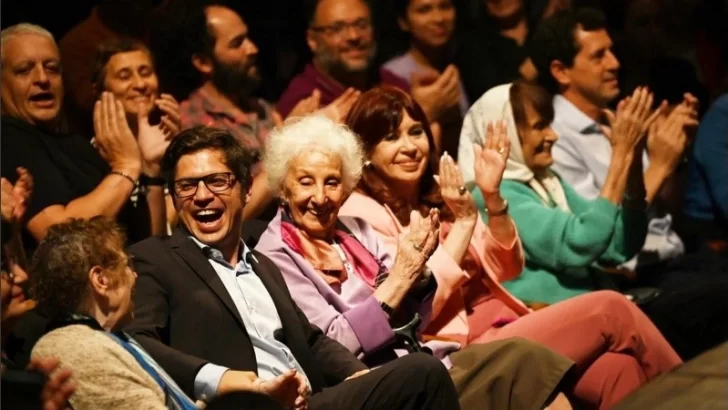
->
<box><xmin>602</xmin><ymin>87</ymin><xmax>660</xmax><ymax>151</ymax></box>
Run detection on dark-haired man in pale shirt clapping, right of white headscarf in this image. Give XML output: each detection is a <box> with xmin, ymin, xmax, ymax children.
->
<box><xmin>533</xmin><ymin>6</ymin><xmax>690</xmax><ymax>270</ymax></box>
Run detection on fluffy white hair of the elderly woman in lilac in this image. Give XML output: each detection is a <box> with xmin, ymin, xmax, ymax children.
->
<box><xmin>263</xmin><ymin>115</ymin><xmax>364</xmax><ymax>193</ymax></box>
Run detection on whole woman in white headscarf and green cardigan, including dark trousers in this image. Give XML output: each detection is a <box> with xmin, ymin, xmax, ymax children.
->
<box><xmin>461</xmin><ymin>82</ymin><xmax>728</xmax><ymax>360</ymax></box>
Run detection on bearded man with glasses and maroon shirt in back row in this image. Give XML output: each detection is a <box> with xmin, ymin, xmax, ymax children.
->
<box><xmin>278</xmin><ymin>0</ymin><xmax>410</xmax><ymax>116</ymax></box>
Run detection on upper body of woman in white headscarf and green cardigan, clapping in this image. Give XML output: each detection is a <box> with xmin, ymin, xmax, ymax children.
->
<box><xmin>466</xmin><ymin>82</ymin><xmax>651</xmax><ymax>304</ymax></box>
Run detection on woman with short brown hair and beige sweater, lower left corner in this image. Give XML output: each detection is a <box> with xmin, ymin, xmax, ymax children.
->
<box><xmin>31</xmin><ymin>217</ymin><xmax>288</xmax><ymax>410</ymax></box>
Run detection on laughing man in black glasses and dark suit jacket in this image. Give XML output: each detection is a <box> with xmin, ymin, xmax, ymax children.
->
<box><xmin>127</xmin><ymin>127</ymin><xmax>459</xmax><ymax>410</ymax></box>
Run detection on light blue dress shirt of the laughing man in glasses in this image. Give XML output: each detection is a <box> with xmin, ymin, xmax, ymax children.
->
<box><xmin>190</xmin><ymin>237</ymin><xmax>311</xmax><ymax>401</ymax></box>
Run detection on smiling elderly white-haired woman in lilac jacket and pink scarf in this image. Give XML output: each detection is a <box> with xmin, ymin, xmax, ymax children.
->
<box><xmin>256</xmin><ymin>116</ymin><xmax>572</xmax><ymax>409</ymax></box>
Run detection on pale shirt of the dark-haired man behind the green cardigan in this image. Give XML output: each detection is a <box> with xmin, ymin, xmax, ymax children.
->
<box><xmin>551</xmin><ymin>95</ymin><xmax>685</xmax><ymax>270</ymax></box>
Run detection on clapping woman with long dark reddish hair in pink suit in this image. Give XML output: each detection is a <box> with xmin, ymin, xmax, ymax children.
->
<box><xmin>341</xmin><ymin>88</ymin><xmax>680</xmax><ymax>408</ymax></box>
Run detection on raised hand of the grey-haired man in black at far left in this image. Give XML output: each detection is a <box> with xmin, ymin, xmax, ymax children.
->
<box><xmin>94</xmin><ymin>92</ymin><xmax>141</xmax><ymax>173</ymax></box>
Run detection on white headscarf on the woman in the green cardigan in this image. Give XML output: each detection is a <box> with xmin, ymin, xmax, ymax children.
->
<box><xmin>461</xmin><ymin>84</ymin><xmax>571</xmax><ymax>212</ymax></box>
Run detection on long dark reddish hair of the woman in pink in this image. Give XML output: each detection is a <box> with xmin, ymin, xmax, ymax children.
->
<box><xmin>346</xmin><ymin>86</ymin><xmax>450</xmax><ymax>225</ymax></box>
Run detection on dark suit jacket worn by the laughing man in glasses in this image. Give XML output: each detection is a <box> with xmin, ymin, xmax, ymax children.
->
<box><xmin>126</xmin><ymin>229</ymin><xmax>366</xmax><ymax>397</ymax></box>
